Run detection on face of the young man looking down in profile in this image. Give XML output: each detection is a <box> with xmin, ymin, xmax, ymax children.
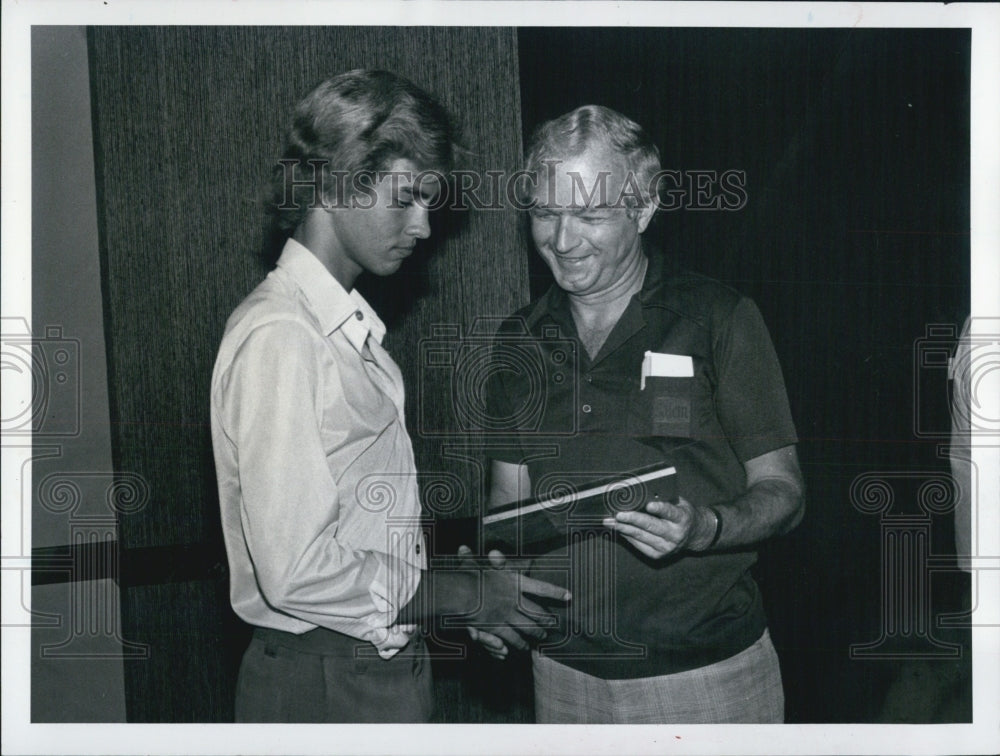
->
<box><xmin>327</xmin><ymin>159</ymin><xmax>440</xmax><ymax>280</ymax></box>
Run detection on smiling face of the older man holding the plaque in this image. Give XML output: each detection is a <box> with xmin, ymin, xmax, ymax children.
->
<box><xmin>530</xmin><ymin>148</ymin><xmax>653</xmax><ymax>297</ymax></box>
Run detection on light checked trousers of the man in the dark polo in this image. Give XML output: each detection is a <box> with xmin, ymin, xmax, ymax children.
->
<box><xmin>532</xmin><ymin>630</ymin><xmax>785</xmax><ymax>724</ymax></box>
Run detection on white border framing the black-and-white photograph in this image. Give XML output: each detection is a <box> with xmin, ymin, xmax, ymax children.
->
<box><xmin>0</xmin><ymin>0</ymin><xmax>1000</xmax><ymax>755</ymax></box>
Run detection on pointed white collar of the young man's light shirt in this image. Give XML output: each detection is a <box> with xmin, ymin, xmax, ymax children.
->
<box><xmin>278</xmin><ymin>239</ymin><xmax>385</xmax><ymax>351</ymax></box>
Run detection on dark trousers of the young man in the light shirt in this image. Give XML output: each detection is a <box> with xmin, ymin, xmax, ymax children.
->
<box><xmin>236</xmin><ymin>628</ymin><xmax>434</xmax><ymax>723</ymax></box>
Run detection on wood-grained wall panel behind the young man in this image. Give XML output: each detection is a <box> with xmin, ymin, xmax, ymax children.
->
<box><xmin>90</xmin><ymin>27</ymin><xmax>527</xmax><ymax>721</ymax></box>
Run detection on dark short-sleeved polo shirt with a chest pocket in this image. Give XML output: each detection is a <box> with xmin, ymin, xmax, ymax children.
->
<box><xmin>485</xmin><ymin>251</ymin><xmax>797</xmax><ymax>679</ymax></box>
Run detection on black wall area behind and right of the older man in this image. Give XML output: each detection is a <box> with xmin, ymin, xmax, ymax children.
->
<box><xmin>519</xmin><ymin>29</ymin><xmax>970</xmax><ymax>722</ymax></box>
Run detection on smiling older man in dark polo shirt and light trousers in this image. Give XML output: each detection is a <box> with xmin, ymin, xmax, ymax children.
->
<box><xmin>478</xmin><ymin>106</ymin><xmax>803</xmax><ymax>723</ymax></box>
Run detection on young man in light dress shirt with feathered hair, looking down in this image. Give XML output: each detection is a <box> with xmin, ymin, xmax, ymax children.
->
<box><xmin>211</xmin><ymin>70</ymin><xmax>565</xmax><ymax>722</ymax></box>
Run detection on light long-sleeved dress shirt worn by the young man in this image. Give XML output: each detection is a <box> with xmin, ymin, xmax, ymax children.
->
<box><xmin>212</xmin><ymin>240</ymin><xmax>426</xmax><ymax>657</ymax></box>
